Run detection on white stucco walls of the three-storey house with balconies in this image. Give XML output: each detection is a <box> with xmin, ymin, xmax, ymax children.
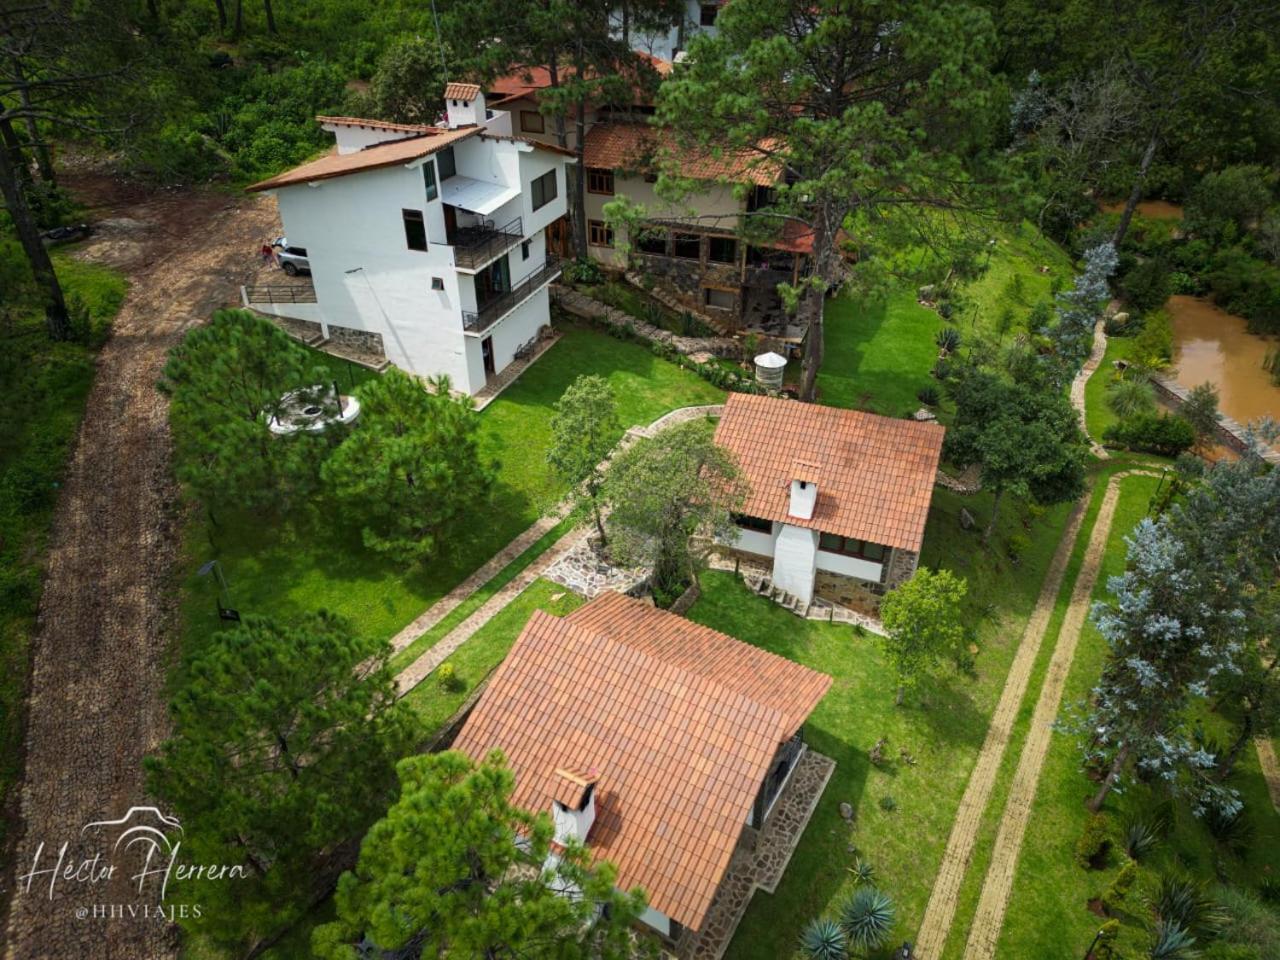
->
<box><xmin>273</xmin><ymin>131</ymin><xmax>566</xmax><ymax>393</ymax></box>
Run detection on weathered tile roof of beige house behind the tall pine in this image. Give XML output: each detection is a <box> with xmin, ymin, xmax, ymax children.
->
<box><xmin>584</xmin><ymin>123</ymin><xmax>778</xmax><ymax>186</ymax></box>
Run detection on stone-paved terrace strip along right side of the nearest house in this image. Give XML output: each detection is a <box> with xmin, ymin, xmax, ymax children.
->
<box><xmin>675</xmin><ymin>749</ymin><xmax>836</xmax><ymax>960</ymax></box>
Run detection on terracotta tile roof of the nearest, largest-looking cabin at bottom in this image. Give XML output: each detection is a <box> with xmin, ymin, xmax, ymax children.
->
<box><xmin>453</xmin><ymin>593</ymin><xmax>831</xmax><ymax>929</ymax></box>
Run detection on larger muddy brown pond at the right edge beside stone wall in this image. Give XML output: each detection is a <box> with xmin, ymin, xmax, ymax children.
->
<box><xmin>1165</xmin><ymin>297</ymin><xmax>1280</xmax><ymax>424</ymax></box>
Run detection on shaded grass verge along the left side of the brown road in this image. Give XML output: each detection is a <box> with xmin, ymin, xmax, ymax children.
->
<box><xmin>0</xmin><ymin>251</ymin><xmax>128</xmax><ymax>845</ymax></box>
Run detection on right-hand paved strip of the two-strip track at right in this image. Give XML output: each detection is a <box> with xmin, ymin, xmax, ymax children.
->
<box><xmin>964</xmin><ymin>470</ymin><xmax>1160</xmax><ymax>960</ymax></box>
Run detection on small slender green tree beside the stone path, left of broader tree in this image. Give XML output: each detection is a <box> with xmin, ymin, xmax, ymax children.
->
<box><xmin>547</xmin><ymin>374</ymin><xmax>622</xmax><ymax>544</ymax></box>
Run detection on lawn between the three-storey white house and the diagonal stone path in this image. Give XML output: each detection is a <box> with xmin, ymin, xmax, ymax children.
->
<box><xmin>175</xmin><ymin>320</ymin><xmax>723</xmax><ymax>653</ymax></box>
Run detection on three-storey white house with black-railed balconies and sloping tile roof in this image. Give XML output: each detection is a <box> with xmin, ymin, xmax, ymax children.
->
<box><xmin>244</xmin><ymin>83</ymin><xmax>571</xmax><ymax>394</ymax></box>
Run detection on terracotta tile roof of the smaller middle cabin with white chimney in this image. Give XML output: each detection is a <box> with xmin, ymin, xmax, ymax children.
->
<box><xmin>716</xmin><ymin>393</ymin><xmax>946</xmax><ymax>550</ymax></box>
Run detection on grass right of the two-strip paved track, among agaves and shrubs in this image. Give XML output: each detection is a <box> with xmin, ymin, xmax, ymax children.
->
<box><xmin>993</xmin><ymin>477</ymin><xmax>1280</xmax><ymax>956</ymax></box>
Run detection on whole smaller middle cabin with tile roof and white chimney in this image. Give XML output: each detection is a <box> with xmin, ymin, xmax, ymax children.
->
<box><xmin>716</xmin><ymin>393</ymin><xmax>946</xmax><ymax>609</ymax></box>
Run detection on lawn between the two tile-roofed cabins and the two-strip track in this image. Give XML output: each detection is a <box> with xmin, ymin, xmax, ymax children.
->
<box><xmin>690</xmin><ymin>478</ymin><xmax>1085</xmax><ymax>960</ymax></box>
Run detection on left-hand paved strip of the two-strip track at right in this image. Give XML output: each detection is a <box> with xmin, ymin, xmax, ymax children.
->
<box><xmin>915</xmin><ymin>497</ymin><xmax>1089</xmax><ymax>960</ymax></box>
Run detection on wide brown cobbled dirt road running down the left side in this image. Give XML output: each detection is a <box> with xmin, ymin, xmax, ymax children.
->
<box><xmin>3</xmin><ymin>174</ymin><xmax>276</xmax><ymax>960</ymax></box>
